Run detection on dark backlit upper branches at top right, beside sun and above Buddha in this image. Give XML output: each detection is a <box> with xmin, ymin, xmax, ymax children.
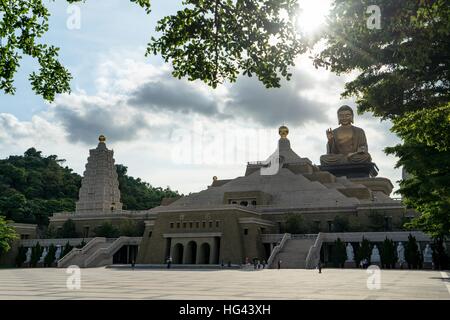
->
<box><xmin>315</xmin><ymin>0</ymin><xmax>450</xmax><ymax>119</ymax></box>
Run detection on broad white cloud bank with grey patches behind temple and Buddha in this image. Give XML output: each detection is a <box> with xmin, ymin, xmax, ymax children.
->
<box><xmin>0</xmin><ymin>52</ymin><xmax>399</xmax><ymax>193</ymax></box>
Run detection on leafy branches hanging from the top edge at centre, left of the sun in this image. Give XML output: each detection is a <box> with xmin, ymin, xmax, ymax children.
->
<box><xmin>147</xmin><ymin>0</ymin><xmax>306</xmax><ymax>88</ymax></box>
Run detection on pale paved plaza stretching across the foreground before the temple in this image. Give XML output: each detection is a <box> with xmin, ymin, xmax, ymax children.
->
<box><xmin>0</xmin><ymin>268</ymin><xmax>450</xmax><ymax>300</ymax></box>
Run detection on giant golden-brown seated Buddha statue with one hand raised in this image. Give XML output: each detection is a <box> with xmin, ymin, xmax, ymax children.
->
<box><xmin>320</xmin><ymin>105</ymin><xmax>372</xmax><ymax>166</ymax></box>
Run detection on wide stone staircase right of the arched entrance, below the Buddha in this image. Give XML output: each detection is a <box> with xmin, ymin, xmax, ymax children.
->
<box><xmin>271</xmin><ymin>236</ymin><xmax>316</xmax><ymax>269</ymax></box>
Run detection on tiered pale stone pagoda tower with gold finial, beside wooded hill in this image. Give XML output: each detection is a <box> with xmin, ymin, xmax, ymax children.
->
<box><xmin>76</xmin><ymin>135</ymin><xmax>122</xmax><ymax>213</ymax></box>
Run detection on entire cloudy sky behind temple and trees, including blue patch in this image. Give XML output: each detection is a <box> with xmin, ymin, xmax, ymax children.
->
<box><xmin>0</xmin><ymin>0</ymin><xmax>401</xmax><ymax>194</ymax></box>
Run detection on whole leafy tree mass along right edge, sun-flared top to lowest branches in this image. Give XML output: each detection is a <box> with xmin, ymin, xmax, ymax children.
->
<box><xmin>314</xmin><ymin>0</ymin><xmax>450</xmax><ymax>237</ymax></box>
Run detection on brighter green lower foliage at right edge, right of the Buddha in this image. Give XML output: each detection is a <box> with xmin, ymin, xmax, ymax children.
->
<box><xmin>386</xmin><ymin>104</ymin><xmax>450</xmax><ymax>239</ymax></box>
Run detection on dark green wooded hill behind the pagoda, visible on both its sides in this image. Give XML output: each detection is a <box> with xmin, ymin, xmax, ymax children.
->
<box><xmin>0</xmin><ymin>148</ymin><xmax>179</xmax><ymax>226</ymax></box>
